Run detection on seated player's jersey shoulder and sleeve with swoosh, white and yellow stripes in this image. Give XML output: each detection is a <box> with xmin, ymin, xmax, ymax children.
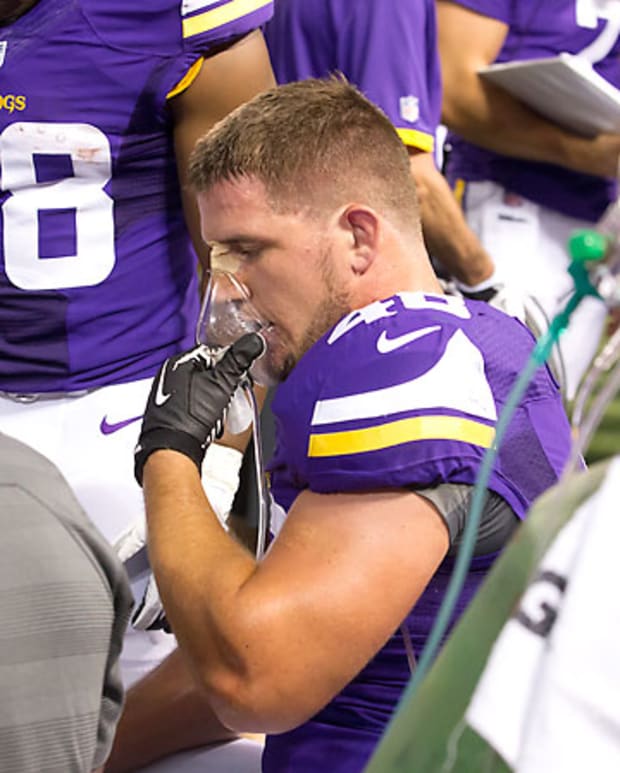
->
<box><xmin>278</xmin><ymin>293</ymin><xmax>497</xmax><ymax>490</ymax></box>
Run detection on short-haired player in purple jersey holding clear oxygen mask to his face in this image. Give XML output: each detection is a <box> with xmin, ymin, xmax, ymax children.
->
<box><xmin>136</xmin><ymin>79</ymin><xmax>571</xmax><ymax>773</ymax></box>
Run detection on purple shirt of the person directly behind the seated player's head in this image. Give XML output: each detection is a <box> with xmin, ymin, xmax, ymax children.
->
<box><xmin>265</xmin><ymin>0</ymin><xmax>441</xmax><ymax>151</ymax></box>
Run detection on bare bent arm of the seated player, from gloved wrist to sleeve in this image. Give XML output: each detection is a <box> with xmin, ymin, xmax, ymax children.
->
<box><xmin>144</xmin><ymin>450</ymin><xmax>448</xmax><ymax>732</ymax></box>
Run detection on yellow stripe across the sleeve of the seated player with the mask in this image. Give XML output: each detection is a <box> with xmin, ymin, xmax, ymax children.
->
<box><xmin>308</xmin><ymin>416</ymin><xmax>495</xmax><ymax>457</ymax></box>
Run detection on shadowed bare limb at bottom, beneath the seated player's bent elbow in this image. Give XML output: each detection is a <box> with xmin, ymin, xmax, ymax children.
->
<box><xmin>104</xmin><ymin>650</ymin><xmax>236</xmax><ymax>773</ymax></box>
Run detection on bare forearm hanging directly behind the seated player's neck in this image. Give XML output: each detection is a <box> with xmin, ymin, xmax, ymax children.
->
<box><xmin>408</xmin><ymin>147</ymin><xmax>494</xmax><ymax>285</ymax></box>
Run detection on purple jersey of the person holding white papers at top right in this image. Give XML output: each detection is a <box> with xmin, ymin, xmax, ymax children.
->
<box><xmin>447</xmin><ymin>0</ymin><xmax>620</xmax><ymax>222</ymax></box>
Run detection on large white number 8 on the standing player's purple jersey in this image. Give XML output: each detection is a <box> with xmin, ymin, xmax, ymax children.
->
<box><xmin>0</xmin><ymin>122</ymin><xmax>116</xmax><ymax>290</ymax></box>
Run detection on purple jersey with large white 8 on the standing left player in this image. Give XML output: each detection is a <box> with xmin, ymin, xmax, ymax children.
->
<box><xmin>0</xmin><ymin>0</ymin><xmax>272</xmax><ymax>392</ymax></box>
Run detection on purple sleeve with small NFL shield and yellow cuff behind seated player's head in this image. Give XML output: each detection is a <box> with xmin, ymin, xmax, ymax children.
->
<box><xmin>338</xmin><ymin>0</ymin><xmax>441</xmax><ymax>151</ymax></box>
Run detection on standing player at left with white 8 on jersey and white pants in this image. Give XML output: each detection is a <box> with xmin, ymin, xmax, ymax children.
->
<box><xmin>0</xmin><ymin>0</ymin><xmax>273</xmax><ymax>768</ymax></box>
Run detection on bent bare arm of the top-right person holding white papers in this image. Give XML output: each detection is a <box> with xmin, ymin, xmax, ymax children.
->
<box><xmin>437</xmin><ymin>0</ymin><xmax>620</xmax><ymax>177</ymax></box>
